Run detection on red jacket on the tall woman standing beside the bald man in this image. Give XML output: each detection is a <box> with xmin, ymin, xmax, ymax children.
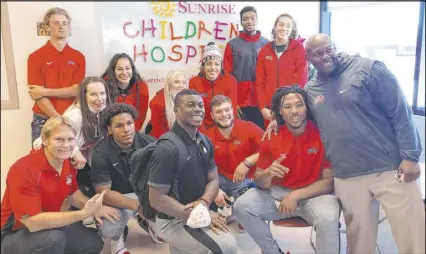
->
<box><xmin>255</xmin><ymin>39</ymin><xmax>308</xmax><ymax>109</ymax></box>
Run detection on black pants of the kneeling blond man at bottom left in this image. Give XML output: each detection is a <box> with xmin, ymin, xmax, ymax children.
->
<box><xmin>1</xmin><ymin>221</ymin><xmax>104</xmax><ymax>254</ymax></box>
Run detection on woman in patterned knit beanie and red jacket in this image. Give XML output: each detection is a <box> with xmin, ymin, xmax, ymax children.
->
<box><xmin>189</xmin><ymin>42</ymin><xmax>238</xmax><ymax>131</ymax></box>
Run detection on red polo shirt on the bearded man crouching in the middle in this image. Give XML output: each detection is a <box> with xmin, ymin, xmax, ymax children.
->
<box><xmin>205</xmin><ymin>119</ymin><xmax>263</xmax><ymax>181</ymax></box>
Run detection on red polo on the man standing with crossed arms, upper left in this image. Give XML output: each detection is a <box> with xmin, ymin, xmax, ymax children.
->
<box><xmin>28</xmin><ymin>41</ymin><xmax>86</xmax><ymax>115</ymax></box>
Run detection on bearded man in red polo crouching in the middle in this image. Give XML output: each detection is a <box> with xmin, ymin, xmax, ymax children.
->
<box><xmin>206</xmin><ymin>95</ymin><xmax>263</xmax><ymax>206</ymax></box>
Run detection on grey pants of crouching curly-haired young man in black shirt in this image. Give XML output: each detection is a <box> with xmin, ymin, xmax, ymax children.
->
<box><xmin>96</xmin><ymin>193</ymin><xmax>138</xmax><ymax>241</ymax></box>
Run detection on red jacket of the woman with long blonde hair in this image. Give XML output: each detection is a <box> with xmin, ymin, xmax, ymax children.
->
<box><xmin>149</xmin><ymin>89</ymin><xmax>169</xmax><ymax>139</ymax></box>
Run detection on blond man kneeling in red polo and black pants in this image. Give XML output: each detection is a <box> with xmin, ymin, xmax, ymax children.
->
<box><xmin>1</xmin><ymin>116</ymin><xmax>115</xmax><ymax>254</ymax></box>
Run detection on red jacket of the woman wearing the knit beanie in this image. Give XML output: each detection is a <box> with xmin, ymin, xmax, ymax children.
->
<box><xmin>189</xmin><ymin>73</ymin><xmax>238</xmax><ymax>129</ymax></box>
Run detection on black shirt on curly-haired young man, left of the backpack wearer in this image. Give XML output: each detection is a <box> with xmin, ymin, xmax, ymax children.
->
<box><xmin>91</xmin><ymin>132</ymin><xmax>156</xmax><ymax>194</ymax></box>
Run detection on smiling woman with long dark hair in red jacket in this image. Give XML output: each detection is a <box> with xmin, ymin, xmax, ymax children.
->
<box><xmin>101</xmin><ymin>53</ymin><xmax>149</xmax><ymax>131</ymax></box>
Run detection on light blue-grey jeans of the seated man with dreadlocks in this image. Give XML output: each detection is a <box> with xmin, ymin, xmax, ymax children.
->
<box><xmin>234</xmin><ymin>186</ymin><xmax>340</xmax><ymax>254</ymax></box>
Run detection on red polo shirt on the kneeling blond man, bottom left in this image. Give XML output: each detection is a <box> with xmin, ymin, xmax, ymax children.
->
<box><xmin>1</xmin><ymin>149</ymin><xmax>78</xmax><ymax>229</ymax></box>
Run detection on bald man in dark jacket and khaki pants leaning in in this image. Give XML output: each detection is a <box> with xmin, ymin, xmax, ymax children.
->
<box><xmin>306</xmin><ymin>34</ymin><xmax>425</xmax><ymax>254</ymax></box>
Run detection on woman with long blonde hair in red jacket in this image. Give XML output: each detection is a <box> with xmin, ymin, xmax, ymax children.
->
<box><xmin>149</xmin><ymin>71</ymin><xmax>188</xmax><ymax>138</ymax></box>
